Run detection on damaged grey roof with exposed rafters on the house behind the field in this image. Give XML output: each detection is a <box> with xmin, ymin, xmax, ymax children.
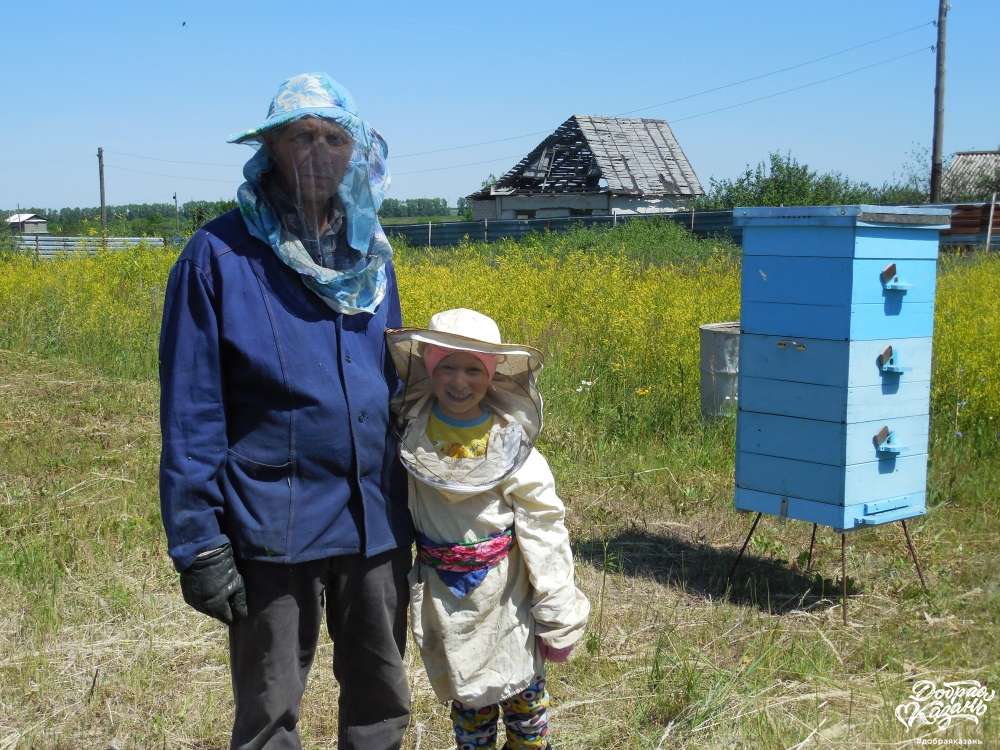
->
<box><xmin>469</xmin><ymin>115</ymin><xmax>704</xmax><ymax>200</ymax></box>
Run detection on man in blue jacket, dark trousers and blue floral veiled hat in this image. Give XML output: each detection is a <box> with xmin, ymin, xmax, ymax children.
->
<box><xmin>160</xmin><ymin>74</ymin><xmax>412</xmax><ymax>750</ymax></box>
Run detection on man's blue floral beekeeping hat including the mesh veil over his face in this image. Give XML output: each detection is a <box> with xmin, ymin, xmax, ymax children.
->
<box><xmin>229</xmin><ymin>73</ymin><xmax>392</xmax><ymax>315</ymax></box>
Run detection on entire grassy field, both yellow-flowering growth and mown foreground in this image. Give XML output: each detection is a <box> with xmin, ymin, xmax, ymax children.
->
<box><xmin>0</xmin><ymin>220</ymin><xmax>1000</xmax><ymax>750</ymax></box>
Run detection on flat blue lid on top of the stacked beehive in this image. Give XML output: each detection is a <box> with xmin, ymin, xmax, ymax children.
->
<box><xmin>733</xmin><ymin>205</ymin><xmax>951</xmax><ymax>230</ymax></box>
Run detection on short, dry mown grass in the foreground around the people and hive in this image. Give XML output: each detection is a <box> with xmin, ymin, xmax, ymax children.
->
<box><xmin>0</xmin><ymin>351</ymin><xmax>1000</xmax><ymax>750</ymax></box>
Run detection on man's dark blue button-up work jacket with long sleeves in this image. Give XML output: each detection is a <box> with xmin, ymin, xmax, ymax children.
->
<box><xmin>160</xmin><ymin>210</ymin><xmax>412</xmax><ymax>570</ymax></box>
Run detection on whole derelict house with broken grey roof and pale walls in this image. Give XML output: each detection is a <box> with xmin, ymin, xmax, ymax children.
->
<box><xmin>468</xmin><ymin>115</ymin><xmax>704</xmax><ymax>219</ymax></box>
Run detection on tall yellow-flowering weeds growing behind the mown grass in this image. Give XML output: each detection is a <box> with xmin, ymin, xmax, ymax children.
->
<box><xmin>0</xmin><ymin>228</ymin><xmax>1000</xmax><ymax>453</ymax></box>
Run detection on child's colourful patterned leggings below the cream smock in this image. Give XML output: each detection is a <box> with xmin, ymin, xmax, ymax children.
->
<box><xmin>451</xmin><ymin>677</ymin><xmax>549</xmax><ymax>750</ymax></box>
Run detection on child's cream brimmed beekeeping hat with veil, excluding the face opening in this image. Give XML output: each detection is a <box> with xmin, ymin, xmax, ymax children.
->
<box><xmin>385</xmin><ymin>308</ymin><xmax>543</xmax><ymax>494</ymax></box>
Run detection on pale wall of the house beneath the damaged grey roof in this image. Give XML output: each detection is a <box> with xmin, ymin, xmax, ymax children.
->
<box><xmin>472</xmin><ymin>193</ymin><xmax>689</xmax><ymax>220</ymax></box>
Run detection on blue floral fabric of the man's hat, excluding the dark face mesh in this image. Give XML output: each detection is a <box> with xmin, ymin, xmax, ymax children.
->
<box><xmin>229</xmin><ymin>73</ymin><xmax>392</xmax><ymax>314</ymax></box>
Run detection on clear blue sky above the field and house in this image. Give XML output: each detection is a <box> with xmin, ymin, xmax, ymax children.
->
<box><xmin>0</xmin><ymin>0</ymin><xmax>1000</xmax><ymax>208</ymax></box>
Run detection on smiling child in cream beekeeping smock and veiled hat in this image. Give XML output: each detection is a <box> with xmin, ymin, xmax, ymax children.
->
<box><xmin>386</xmin><ymin>309</ymin><xmax>590</xmax><ymax>750</ymax></box>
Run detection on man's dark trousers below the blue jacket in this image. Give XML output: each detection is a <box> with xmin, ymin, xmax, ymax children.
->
<box><xmin>229</xmin><ymin>549</ymin><xmax>410</xmax><ymax>750</ymax></box>
